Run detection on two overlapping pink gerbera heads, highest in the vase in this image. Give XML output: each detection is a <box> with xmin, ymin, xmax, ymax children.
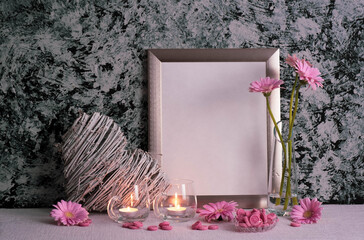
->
<box><xmin>286</xmin><ymin>54</ymin><xmax>324</xmax><ymax>90</ymax></box>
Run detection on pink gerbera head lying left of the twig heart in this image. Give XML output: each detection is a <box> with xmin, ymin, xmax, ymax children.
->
<box><xmin>51</xmin><ymin>200</ymin><xmax>88</xmax><ymax>226</ymax></box>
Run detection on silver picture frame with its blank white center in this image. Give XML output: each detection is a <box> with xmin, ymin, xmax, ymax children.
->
<box><xmin>148</xmin><ymin>48</ymin><xmax>280</xmax><ymax>208</ymax></box>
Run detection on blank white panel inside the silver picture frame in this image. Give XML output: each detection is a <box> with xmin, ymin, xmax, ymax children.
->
<box><xmin>161</xmin><ymin>62</ymin><xmax>267</xmax><ymax>195</ymax></box>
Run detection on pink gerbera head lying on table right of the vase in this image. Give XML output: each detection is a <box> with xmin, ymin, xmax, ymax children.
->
<box><xmin>291</xmin><ymin>198</ymin><xmax>323</xmax><ymax>224</ymax></box>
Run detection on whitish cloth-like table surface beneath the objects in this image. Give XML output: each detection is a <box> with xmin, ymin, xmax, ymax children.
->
<box><xmin>0</xmin><ymin>205</ymin><xmax>364</xmax><ymax>240</ymax></box>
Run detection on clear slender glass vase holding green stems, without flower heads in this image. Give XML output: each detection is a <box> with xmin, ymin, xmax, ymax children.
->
<box><xmin>268</xmin><ymin>120</ymin><xmax>298</xmax><ymax>216</ymax></box>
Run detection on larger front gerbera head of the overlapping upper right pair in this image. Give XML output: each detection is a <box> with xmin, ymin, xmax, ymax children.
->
<box><xmin>296</xmin><ymin>60</ymin><xmax>324</xmax><ymax>90</ymax></box>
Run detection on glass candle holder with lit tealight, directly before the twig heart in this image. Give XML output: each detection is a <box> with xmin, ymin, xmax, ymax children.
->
<box><xmin>107</xmin><ymin>180</ymin><xmax>150</xmax><ymax>223</ymax></box>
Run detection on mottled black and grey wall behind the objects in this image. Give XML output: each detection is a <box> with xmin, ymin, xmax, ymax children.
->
<box><xmin>0</xmin><ymin>0</ymin><xmax>364</xmax><ymax>207</ymax></box>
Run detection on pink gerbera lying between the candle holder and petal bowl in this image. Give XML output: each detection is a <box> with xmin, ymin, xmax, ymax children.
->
<box><xmin>200</xmin><ymin>201</ymin><xmax>238</xmax><ymax>222</ymax></box>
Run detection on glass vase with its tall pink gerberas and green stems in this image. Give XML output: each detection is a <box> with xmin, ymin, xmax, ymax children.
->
<box><xmin>249</xmin><ymin>54</ymin><xmax>324</xmax><ymax>216</ymax></box>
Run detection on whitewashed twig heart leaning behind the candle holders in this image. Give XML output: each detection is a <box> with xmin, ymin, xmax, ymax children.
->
<box><xmin>62</xmin><ymin>112</ymin><xmax>167</xmax><ymax>211</ymax></box>
